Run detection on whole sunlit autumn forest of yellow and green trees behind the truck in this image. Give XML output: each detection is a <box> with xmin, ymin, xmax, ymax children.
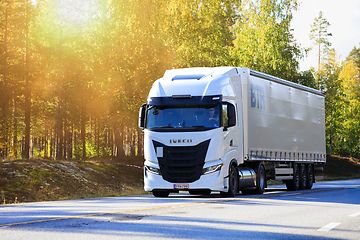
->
<box><xmin>0</xmin><ymin>0</ymin><xmax>360</xmax><ymax>160</ymax></box>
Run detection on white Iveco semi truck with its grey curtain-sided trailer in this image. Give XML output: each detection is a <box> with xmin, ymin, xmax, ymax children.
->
<box><xmin>139</xmin><ymin>67</ymin><xmax>326</xmax><ymax>197</ymax></box>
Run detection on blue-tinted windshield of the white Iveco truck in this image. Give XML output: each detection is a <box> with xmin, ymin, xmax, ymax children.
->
<box><xmin>147</xmin><ymin>104</ymin><xmax>221</xmax><ymax>131</ymax></box>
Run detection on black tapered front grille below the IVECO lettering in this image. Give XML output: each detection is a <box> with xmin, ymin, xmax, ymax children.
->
<box><xmin>153</xmin><ymin>140</ymin><xmax>210</xmax><ymax>183</ymax></box>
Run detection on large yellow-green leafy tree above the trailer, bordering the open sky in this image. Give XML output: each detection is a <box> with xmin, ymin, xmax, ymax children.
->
<box><xmin>231</xmin><ymin>0</ymin><xmax>301</xmax><ymax>80</ymax></box>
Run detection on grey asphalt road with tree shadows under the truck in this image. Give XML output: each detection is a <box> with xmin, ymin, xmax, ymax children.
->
<box><xmin>0</xmin><ymin>179</ymin><xmax>360</xmax><ymax>240</ymax></box>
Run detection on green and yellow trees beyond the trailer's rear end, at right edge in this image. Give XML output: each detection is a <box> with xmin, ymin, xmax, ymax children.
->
<box><xmin>316</xmin><ymin>50</ymin><xmax>360</xmax><ymax>157</ymax></box>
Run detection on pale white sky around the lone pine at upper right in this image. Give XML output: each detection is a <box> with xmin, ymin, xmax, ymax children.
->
<box><xmin>291</xmin><ymin>0</ymin><xmax>360</xmax><ymax>71</ymax></box>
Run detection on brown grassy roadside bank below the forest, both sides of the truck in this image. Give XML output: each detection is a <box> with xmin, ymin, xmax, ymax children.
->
<box><xmin>0</xmin><ymin>155</ymin><xmax>360</xmax><ymax>204</ymax></box>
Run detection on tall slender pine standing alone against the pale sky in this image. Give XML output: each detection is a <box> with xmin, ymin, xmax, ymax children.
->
<box><xmin>309</xmin><ymin>11</ymin><xmax>332</xmax><ymax>71</ymax></box>
